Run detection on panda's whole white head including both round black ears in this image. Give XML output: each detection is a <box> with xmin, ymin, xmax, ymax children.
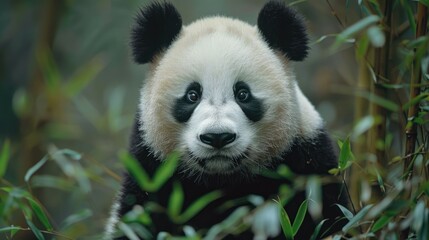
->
<box><xmin>132</xmin><ymin>1</ymin><xmax>321</xmax><ymax>175</ymax></box>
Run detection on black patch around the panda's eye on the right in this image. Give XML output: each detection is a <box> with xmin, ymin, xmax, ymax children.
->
<box><xmin>233</xmin><ymin>81</ymin><xmax>265</xmax><ymax>122</ymax></box>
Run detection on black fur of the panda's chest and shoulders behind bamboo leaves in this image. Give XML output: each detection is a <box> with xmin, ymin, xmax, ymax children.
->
<box><xmin>113</xmin><ymin>118</ymin><xmax>348</xmax><ymax>239</ymax></box>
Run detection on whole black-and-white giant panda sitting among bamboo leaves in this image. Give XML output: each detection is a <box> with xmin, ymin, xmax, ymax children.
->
<box><xmin>106</xmin><ymin>1</ymin><xmax>347</xmax><ymax>239</ymax></box>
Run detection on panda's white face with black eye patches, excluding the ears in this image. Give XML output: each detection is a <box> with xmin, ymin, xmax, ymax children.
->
<box><xmin>140</xmin><ymin>18</ymin><xmax>299</xmax><ymax>174</ymax></box>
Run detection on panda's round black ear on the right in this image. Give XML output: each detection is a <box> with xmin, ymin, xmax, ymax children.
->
<box><xmin>258</xmin><ymin>1</ymin><xmax>308</xmax><ymax>61</ymax></box>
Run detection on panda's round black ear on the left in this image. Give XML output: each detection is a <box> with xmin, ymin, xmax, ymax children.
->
<box><xmin>131</xmin><ymin>2</ymin><xmax>182</xmax><ymax>64</ymax></box>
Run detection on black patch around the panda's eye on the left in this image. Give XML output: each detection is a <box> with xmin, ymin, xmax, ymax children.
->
<box><xmin>173</xmin><ymin>82</ymin><xmax>202</xmax><ymax>123</ymax></box>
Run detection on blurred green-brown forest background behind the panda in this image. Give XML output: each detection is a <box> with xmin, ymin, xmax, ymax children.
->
<box><xmin>0</xmin><ymin>0</ymin><xmax>416</xmax><ymax>239</ymax></box>
